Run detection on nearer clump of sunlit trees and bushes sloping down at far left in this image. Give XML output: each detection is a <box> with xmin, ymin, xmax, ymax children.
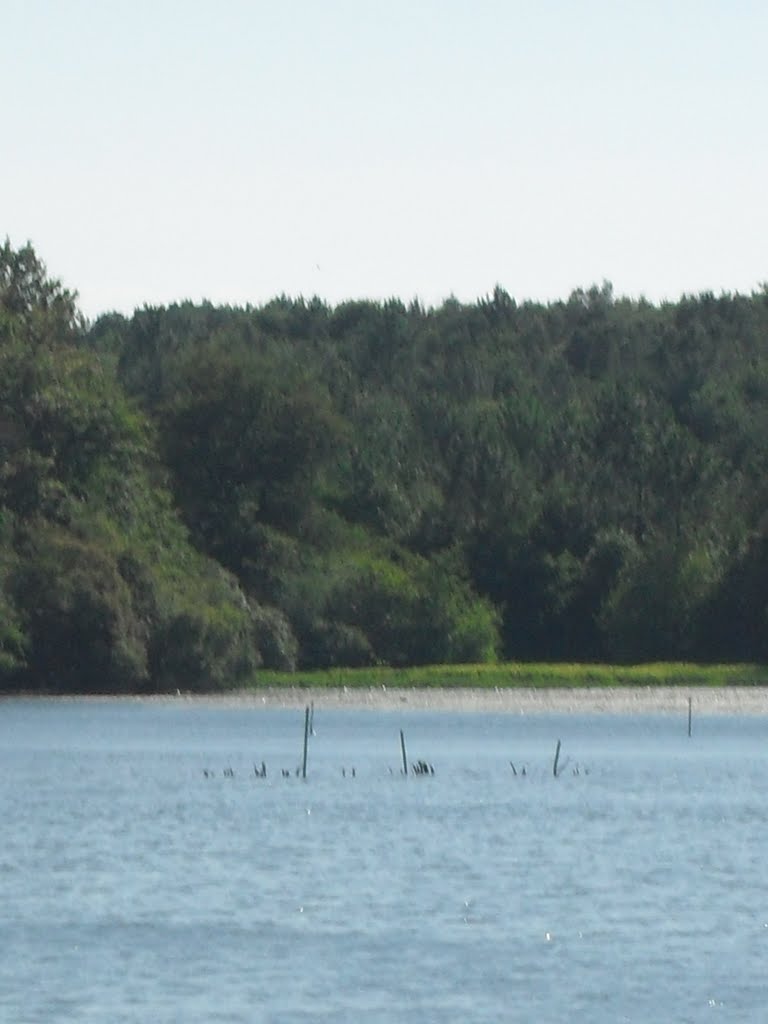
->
<box><xmin>0</xmin><ymin>243</ymin><xmax>259</xmax><ymax>691</ymax></box>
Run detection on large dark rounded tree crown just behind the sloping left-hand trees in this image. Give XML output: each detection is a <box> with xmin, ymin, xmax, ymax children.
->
<box><xmin>160</xmin><ymin>346</ymin><xmax>339</xmax><ymax>552</ymax></box>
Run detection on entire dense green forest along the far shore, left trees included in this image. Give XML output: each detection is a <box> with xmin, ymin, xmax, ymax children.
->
<box><xmin>0</xmin><ymin>242</ymin><xmax>768</xmax><ymax>692</ymax></box>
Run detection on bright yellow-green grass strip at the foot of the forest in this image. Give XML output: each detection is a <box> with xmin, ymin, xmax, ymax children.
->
<box><xmin>247</xmin><ymin>662</ymin><xmax>768</xmax><ymax>689</ymax></box>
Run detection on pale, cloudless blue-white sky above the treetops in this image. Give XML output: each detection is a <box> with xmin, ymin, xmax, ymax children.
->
<box><xmin>0</xmin><ymin>0</ymin><xmax>768</xmax><ymax>318</ymax></box>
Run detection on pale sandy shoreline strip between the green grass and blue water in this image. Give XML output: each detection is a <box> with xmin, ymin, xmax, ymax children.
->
<box><xmin>12</xmin><ymin>686</ymin><xmax>768</xmax><ymax>715</ymax></box>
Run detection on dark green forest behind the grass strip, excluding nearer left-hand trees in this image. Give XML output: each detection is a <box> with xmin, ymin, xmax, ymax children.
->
<box><xmin>94</xmin><ymin>272</ymin><xmax>768</xmax><ymax>667</ymax></box>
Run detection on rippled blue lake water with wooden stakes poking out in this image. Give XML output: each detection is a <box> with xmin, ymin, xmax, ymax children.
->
<box><xmin>0</xmin><ymin>700</ymin><xmax>768</xmax><ymax>1024</ymax></box>
